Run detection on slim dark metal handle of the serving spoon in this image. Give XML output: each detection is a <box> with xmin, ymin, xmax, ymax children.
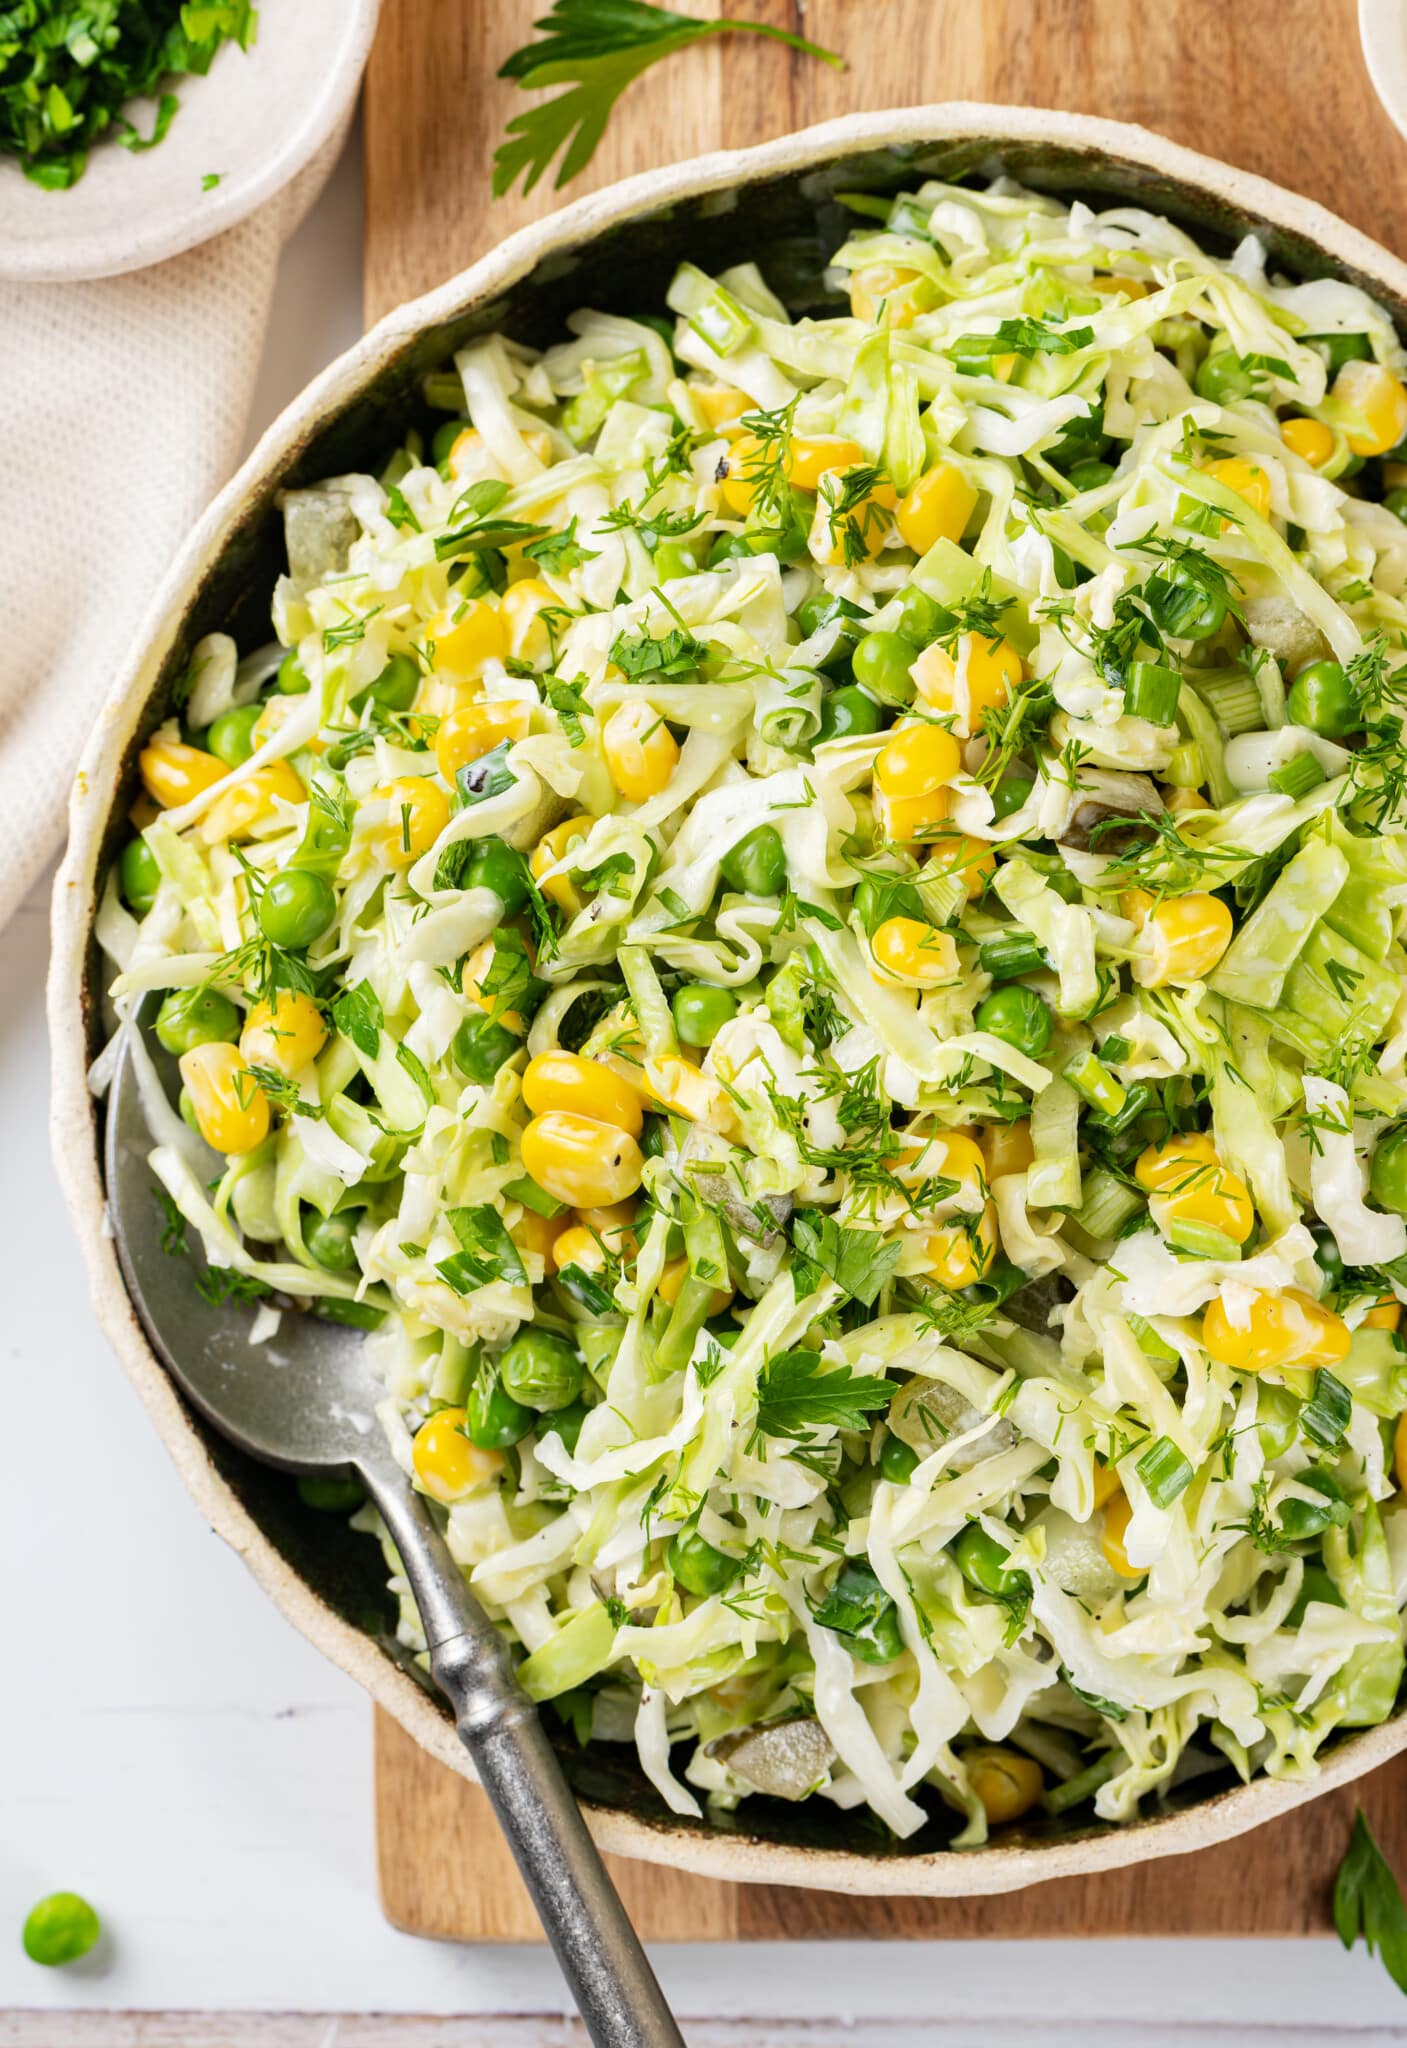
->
<box><xmin>363</xmin><ymin>1470</ymin><xmax>684</xmax><ymax>2048</ymax></box>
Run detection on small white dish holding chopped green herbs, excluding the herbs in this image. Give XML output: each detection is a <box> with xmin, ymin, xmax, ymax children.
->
<box><xmin>0</xmin><ymin>0</ymin><xmax>381</xmax><ymax>285</ymax></box>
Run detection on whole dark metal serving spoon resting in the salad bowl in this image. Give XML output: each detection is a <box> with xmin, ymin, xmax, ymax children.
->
<box><xmin>106</xmin><ymin>1024</ymin><xmax>684</xmax><ymax>2048</ymax></box>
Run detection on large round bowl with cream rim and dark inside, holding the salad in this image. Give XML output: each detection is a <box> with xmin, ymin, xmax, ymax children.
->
<box><xmin>49</xmin><ymin>104</ymin><xmax>1407</xmax><ymax>1896</ymax></box>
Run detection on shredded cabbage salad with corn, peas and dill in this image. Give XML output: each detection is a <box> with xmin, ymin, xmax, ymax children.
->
<box><xmin>96</xmin><ymin>180</ymin><xmax>1407</xmax><ymax>1847</ymax></box>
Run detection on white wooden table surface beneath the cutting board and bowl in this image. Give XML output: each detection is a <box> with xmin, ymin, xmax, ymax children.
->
<box><xmin>0</xmin><ymin>119</ymin><xmax>1407</xmax><ymax>2048</ymax></box>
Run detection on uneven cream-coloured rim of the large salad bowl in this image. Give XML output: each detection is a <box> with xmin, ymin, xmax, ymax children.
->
<box><xmin>47</xmin><ymin>100</ymin><xmax>1407</xmax><ymax>1898</ymax></box>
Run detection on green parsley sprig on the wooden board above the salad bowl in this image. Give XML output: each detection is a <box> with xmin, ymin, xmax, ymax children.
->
<box><xmin>494</xmin><ymin>0</ymin><xmax>844</xmax><ymax>197</ymax></box>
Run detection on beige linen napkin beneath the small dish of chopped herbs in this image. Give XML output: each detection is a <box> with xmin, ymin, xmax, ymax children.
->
<box><xmin>0</xmin><ymin>127</ymin><xmax>346</xmax><ymax>924</ymax></box>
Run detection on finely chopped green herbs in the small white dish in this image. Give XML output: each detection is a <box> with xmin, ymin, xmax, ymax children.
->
<box><xmin>0</xmin><ymin>0</ymin><xmax>258</xmax><ymax>190</ymax></box>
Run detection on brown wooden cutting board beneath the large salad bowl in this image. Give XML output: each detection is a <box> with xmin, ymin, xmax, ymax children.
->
<box><xmin>367</xmin><ymin>0</ymin><xmax>1407</xmax><ymax>1942</ymax></box>
